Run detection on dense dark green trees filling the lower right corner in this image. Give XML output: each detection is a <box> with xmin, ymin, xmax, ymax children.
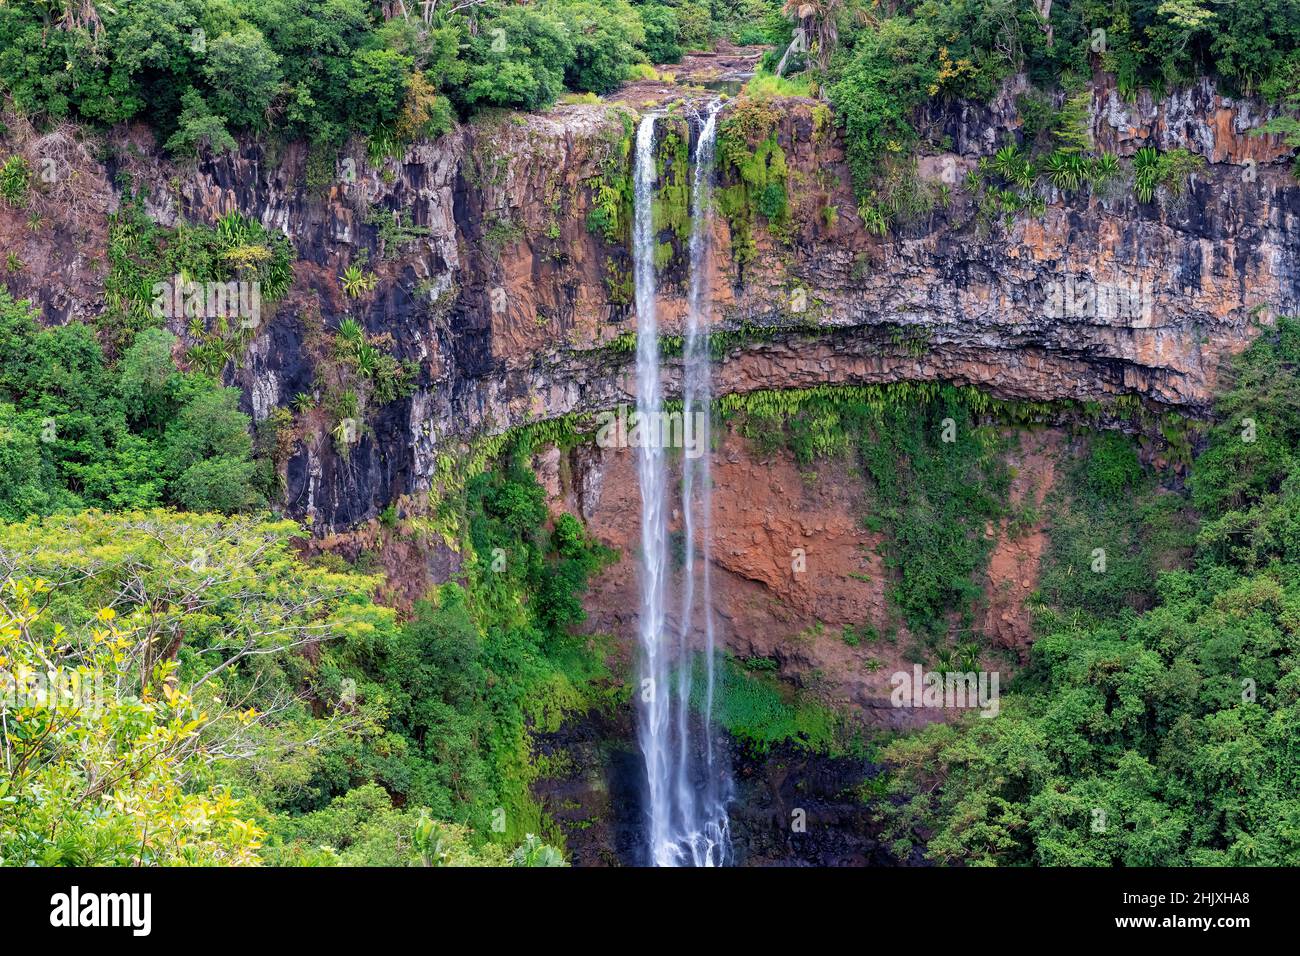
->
<box><xmin>885</xmin><ymin>320</ymin><xmax>1300</xmax><ymax>866</ymax></box>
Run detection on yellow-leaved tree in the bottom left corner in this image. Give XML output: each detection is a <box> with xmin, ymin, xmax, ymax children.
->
<box><xmin>0</xmin><ymin>575</ymin><xmax>264</xmax><ymax>866</ymax></box>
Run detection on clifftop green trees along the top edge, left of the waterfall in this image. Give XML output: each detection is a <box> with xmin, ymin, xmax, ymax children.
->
<box><xmin>0</xmin><ymin>0</ymin><xmax>759</xmax><ymax>155</ymax></box>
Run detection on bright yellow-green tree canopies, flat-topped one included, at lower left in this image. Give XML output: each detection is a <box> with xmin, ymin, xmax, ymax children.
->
<box><xmin>0</xmin><ymin>511</ymin><xmax>391</xmax><ymax>865</ymax></box>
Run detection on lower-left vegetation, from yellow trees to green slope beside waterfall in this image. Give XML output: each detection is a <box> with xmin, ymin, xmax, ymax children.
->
<box><xmin>0</xmin><ymin>437</ymin><xmax>614</xmax><ymax>865</ymax></box>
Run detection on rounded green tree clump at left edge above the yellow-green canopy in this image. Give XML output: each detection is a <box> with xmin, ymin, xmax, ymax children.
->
<box><xmin>0</xmin><ymin>289</ymin><xmax>261</xmax><ymax>520</ymax></box>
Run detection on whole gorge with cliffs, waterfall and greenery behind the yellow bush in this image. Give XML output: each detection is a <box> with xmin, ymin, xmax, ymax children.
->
<box><xmin>0</xmin><ymin>5</ymin><xmax>1300</xmax><ymax>866</ymax></box>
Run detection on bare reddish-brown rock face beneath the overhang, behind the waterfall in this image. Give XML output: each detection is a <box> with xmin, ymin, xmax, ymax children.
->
<box><xmin>536</xmin><ymin>428</ymin><xmax>1063</xmax><ymax>727</ymax></box>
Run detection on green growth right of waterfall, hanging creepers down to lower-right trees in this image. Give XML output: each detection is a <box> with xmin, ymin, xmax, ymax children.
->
<box><xmin>736</xmin><ymin>319</ymin><xmax>1300</xmax><ymax>866</ymax></box>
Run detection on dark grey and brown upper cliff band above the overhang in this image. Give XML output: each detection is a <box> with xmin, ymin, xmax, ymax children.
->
<box><xmin>0</xmin><ymin>77</ymin><xmax>1300</xmax><ymax>531</ymax></box>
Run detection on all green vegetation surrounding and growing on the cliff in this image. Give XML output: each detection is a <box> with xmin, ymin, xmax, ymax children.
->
<box><xmin>0</xmin><ymin>0</ymin><xmax>1300</xmax><ymax>866</ymax></box>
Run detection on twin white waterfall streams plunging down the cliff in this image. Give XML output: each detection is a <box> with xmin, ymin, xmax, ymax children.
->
<box><xmin>632</xmin><ymin>103</ymin><xmax>731</xmax><ymax>866</ymax></box>
